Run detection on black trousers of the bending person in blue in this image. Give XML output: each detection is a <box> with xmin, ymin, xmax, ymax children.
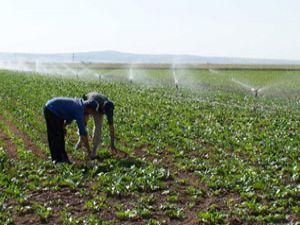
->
<box><xmin>44</xmin><ymin>107</ymin><xmax>69</xmax><ymax>162</ymax></box>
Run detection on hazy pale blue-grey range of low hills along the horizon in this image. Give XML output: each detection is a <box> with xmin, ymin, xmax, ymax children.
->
<box><xmin>0</xmin><ymin>51</ymin><xmax>300</xmax><ymax>65</ymax></box>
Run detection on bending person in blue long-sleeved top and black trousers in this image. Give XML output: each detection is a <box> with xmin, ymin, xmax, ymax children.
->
<box><xmin>44</xmin><ymin>98</ymin><xmax>99</xmax><ymax>163</ymax></box>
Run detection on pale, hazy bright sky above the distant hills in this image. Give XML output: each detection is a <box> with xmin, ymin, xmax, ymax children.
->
<box><xmin>0</xmin><ymin>0</ymin><xmax>300</xmax><ymax>60</ymax></box>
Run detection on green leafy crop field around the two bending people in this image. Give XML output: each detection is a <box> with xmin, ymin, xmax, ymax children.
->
<box><xmin>0</xmin><ymin>68</ymin><xmax>300</xmax><ymax>225</ymax></box>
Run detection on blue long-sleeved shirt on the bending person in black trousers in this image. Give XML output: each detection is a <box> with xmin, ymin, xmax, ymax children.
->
<box><xmin>46</xmin><ymin>98</ymin><xmax>87</xmax><ymax>136</ymax></box>
